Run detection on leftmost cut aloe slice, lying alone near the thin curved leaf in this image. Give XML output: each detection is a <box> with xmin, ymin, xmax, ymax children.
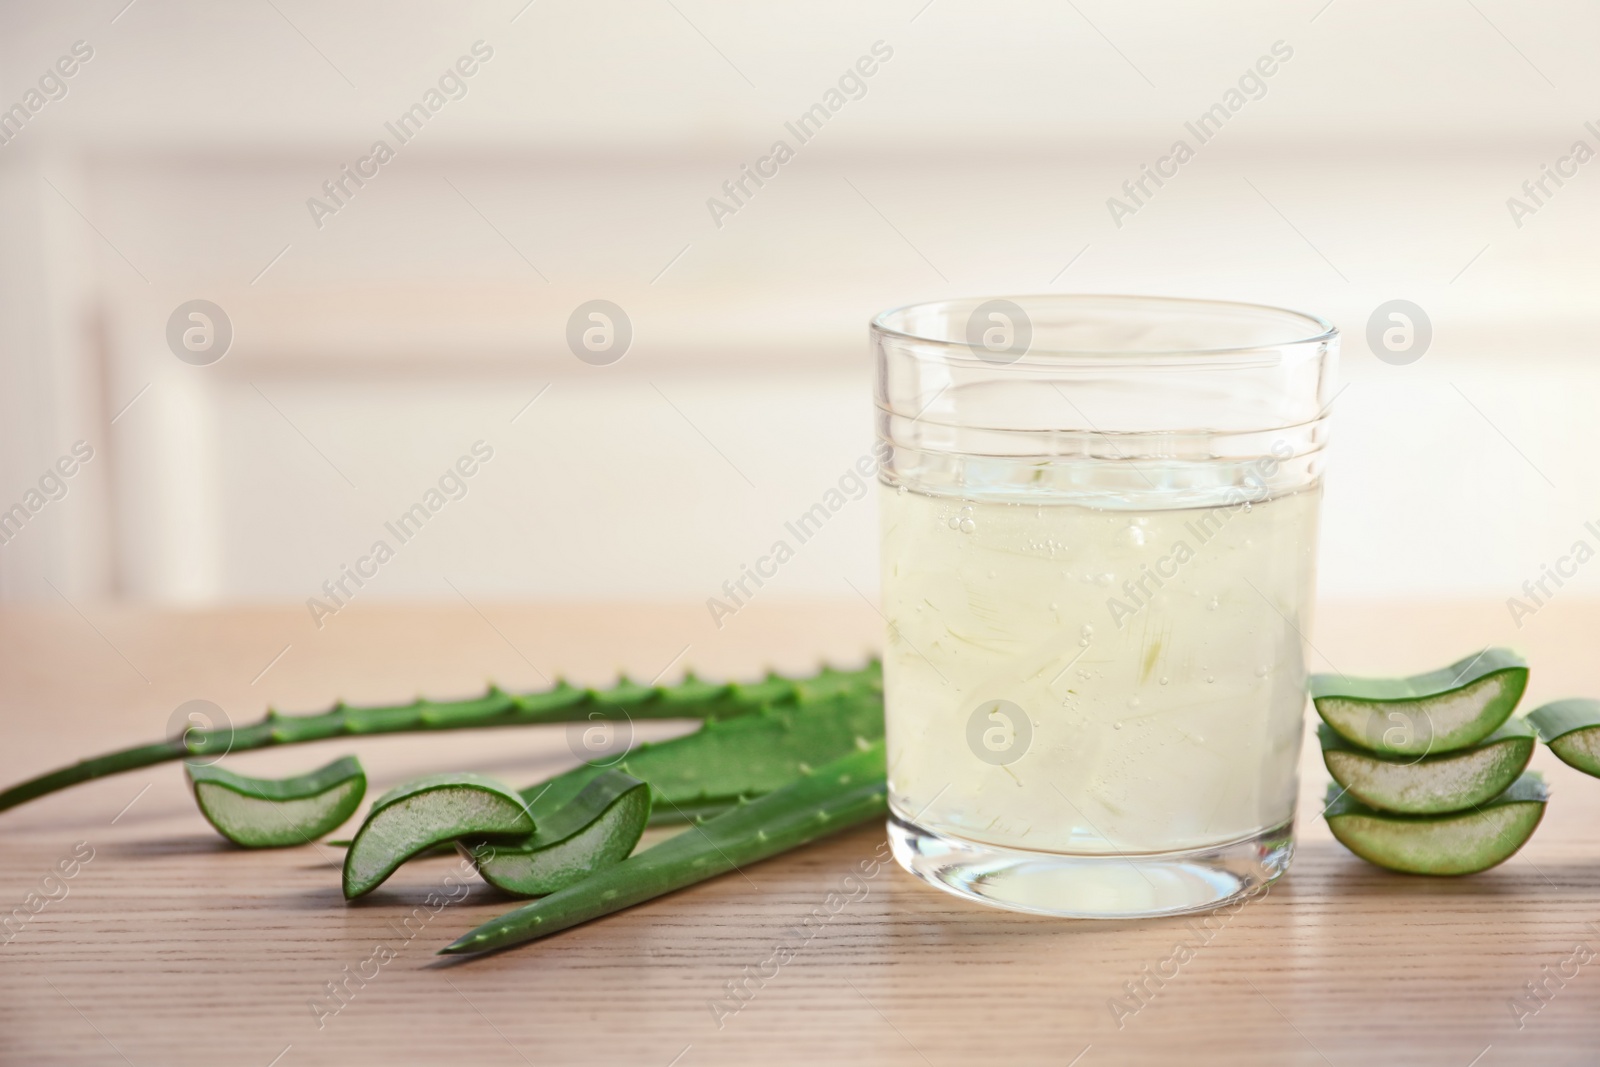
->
<box><xmin>184</xmin><ymin>757</ymin><xmax>366</xmax><ymax>848</ymax></box>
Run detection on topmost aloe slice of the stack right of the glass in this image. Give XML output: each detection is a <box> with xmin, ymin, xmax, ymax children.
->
<box><xmin>1310</xmin><ymin>648</ymin><xmax>1528</xmax><ymax>755</ymax></box>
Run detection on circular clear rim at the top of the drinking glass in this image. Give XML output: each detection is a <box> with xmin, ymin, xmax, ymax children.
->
<box><xmin>869</xmin><ymin>293</ymin><xmax>1339</xmax><ymax>366</ymax></box>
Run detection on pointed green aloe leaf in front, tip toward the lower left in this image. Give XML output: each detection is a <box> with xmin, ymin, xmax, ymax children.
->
<box><xmin>440</xmin><ymin>741</ymin><xmax>888</xmax><ymax>955</ymax></box>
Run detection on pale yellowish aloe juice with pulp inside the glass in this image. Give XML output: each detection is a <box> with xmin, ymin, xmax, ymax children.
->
<box><xmin>882</xmin><ymin>486</ymin><xmax>1320</xmax><ymax>854</ymax></box>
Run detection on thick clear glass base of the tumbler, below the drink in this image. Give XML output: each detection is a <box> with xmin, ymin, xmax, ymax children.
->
<box><xmin>888</xmin><ymin>809</ymin><xmax>1294</xmax><ymax>918</ymax></box>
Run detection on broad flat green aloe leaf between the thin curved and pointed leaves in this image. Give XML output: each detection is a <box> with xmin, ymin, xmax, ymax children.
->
<box><xmin>522</xmin><ymin>693</ymin><xmax>883</xmax><ymax>825</ymax></box>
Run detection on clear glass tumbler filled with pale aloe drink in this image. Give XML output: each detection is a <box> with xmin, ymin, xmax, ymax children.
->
<box><xmin>872</xmin><ymin>296</ymin><xmax>1338</xmax><ymax>917</ymax></box>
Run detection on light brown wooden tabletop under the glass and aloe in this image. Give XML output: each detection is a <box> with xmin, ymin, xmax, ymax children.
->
<box><xmin>0</xmin><ymin>600</ymin><xmax>1600</xmax><ymax>1067</ymax></box>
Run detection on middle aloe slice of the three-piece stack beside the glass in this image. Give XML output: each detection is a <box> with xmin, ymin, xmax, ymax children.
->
<box><xmin>1317</xmin><ymin>718</ymin><xmax>1534</xmax><ymax>814</ymax></box>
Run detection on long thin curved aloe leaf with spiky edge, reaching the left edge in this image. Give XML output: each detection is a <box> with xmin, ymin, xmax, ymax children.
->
<box><xmin>0</xmin><ymin>661</ymin><xmax>883</xmax><ymax>811</ymax></box>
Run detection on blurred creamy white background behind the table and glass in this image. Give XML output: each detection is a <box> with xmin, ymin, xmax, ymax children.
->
<box><xmin>0</xmin><ymin>0</ymin><xmax>1600</xmax><ymax>617</ymax></box>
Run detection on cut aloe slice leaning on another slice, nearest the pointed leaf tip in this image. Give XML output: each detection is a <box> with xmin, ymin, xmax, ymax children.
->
<box><xmin>456</xmin><ymin>771</ymin><xmax>650</xmax><ymax>896</ymax></box>
